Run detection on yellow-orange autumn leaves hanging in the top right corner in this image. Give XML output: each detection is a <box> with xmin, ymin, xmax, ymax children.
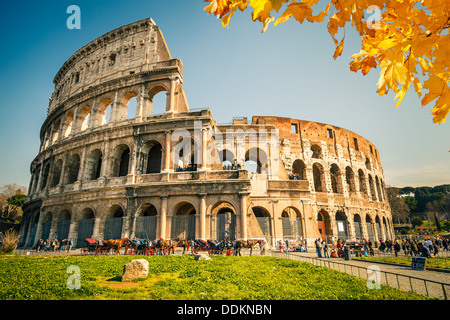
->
<box><xmin>204</xmin><ymin>0</ymin><xmax>450</xmax><ymax>123</ymax></box>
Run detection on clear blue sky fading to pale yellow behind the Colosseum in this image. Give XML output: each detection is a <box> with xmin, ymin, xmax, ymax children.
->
<box><xmin>0</xmin><ymin>0</ymin><xmax>450</xmax><ymax>187</ymax></box>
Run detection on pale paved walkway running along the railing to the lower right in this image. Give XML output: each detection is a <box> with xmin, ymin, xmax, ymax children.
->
<box><xmin>270</xmin><ymin>251</ymin><xmax>450</xmax><ymax>300</ymax></box>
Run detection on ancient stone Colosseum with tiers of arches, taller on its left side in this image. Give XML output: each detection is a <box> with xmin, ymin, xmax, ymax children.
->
<box><xmin>19</xmin><ymin>18</ymin><xmax>394</xmax><ymax>248</ymax></box>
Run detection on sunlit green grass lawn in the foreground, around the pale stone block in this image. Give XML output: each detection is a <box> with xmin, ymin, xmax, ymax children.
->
<box><xmin>0</xmin><ymin>255</ymin><xmax>426</xmax><ymax>300</ymax></box>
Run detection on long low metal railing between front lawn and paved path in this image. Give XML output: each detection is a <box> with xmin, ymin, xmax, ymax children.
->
<box><xmin>270</xmin><ymin>251</ymin><xmax>450</xmax><ymax>300</ymax></box>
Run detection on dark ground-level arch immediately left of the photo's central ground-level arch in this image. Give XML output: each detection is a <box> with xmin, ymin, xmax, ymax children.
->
<box><xmin>171</xmin><ymin>202</ymin><xmax>196</xmax><ymax>239</ymax></box>
